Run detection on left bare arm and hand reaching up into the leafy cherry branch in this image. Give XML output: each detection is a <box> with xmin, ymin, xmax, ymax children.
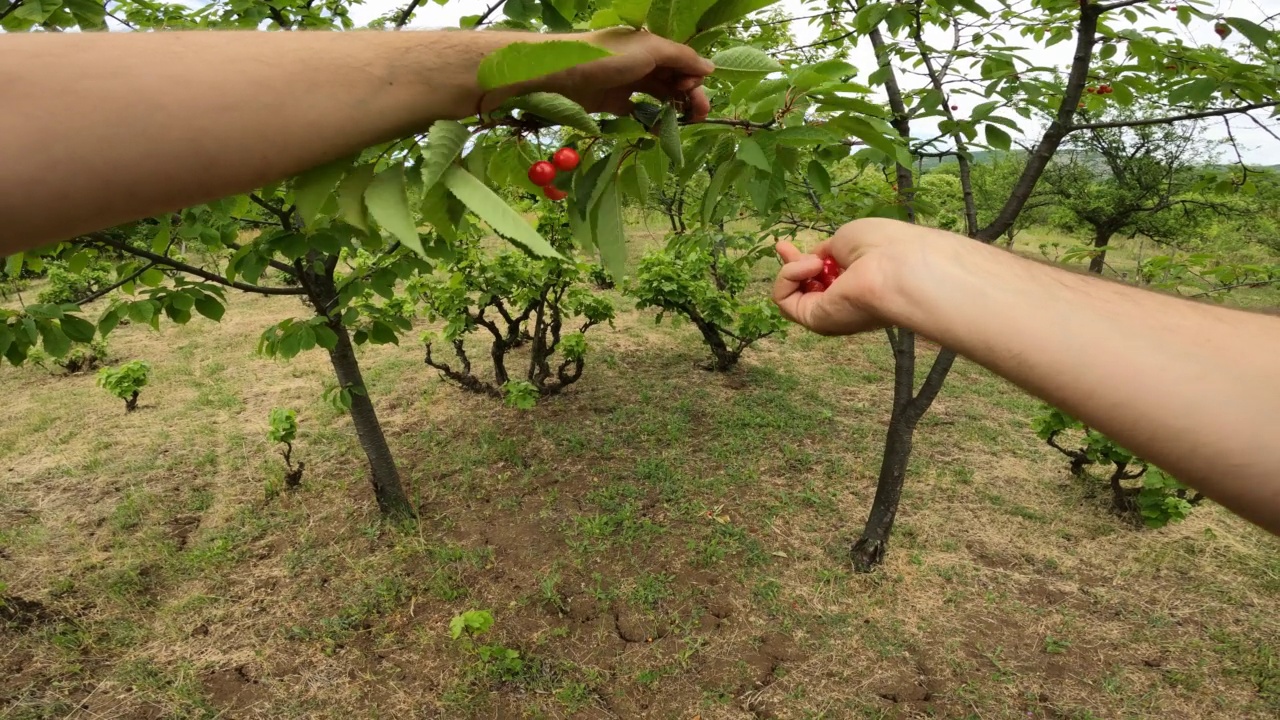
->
<box><xmin>0</xmin><ymin>31</ymin><xmax>713</xmax><ymax>256</ymax></box>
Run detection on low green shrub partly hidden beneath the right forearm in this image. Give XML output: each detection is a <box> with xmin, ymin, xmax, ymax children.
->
<box><xmin>1032</xmin><ymin>405</ymin><xmax>1204</xmax><ymax>528</ymax></box>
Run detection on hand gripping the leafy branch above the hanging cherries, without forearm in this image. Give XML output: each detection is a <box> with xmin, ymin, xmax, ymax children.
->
<box><xmin>483</xmin><ymin>28</ymin><xmax>716</xmax><ymax>123</ymax></box>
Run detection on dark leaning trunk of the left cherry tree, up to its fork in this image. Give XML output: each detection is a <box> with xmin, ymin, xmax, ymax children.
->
<box><xmin>296</xmin><ymin>251</ymin><xmax>415</xmax><ymax>519</ymax></box>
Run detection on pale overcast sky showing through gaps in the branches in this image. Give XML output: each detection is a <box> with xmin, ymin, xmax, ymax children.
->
<box><xmin>351</xmin><ymin>0</ymin><xmax>1280</xmax><ymax>165</ymax></box>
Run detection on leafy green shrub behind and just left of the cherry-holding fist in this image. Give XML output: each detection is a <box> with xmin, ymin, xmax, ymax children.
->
<box><xmin>627</xmin><ymin>229</ymin><xmax>786</xmax><ymax>372</ymax></box>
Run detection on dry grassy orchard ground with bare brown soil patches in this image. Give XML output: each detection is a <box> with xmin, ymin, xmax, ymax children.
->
<box><xmin>0</xmin><ymin>219</ymin><xmax>1280</xmax><ymax>720</ymax></box>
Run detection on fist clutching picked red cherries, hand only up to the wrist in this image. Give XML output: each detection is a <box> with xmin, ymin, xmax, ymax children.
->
<box><xmin>773</xmin><ymin>218</ymin><xmax>928</xmax><ymax>336</ymax></box>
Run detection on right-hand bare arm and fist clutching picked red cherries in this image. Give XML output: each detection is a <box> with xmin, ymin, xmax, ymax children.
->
<box><xmin>774</xmin><ymin>219</ymin><xmax>1280</xmax><ymax>534</ymax></box>
